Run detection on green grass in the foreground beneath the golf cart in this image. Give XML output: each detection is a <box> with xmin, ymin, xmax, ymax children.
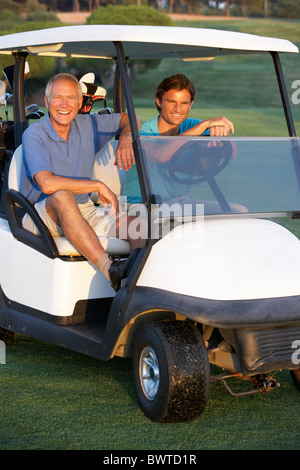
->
<box><xmin>0</xmin><ymin>335</ymin><xmax>300</xmax><ymax>451</ymax></box>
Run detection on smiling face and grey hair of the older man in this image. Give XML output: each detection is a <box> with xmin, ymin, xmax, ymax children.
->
<box><xmin>45</xmin><ymin>79</ymin><xmax>81</xmax><ymax>128</ymax></box>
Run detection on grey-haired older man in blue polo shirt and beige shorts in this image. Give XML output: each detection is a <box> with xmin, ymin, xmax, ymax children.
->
<box><xmin>22</xmin><ymin>74</ymin><xmax>140</xmax><ymax>290</ymax></box>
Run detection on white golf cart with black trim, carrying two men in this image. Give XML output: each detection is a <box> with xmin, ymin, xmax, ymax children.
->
<box><xmin>0</xmin><ymin>25</ymin><xmax>300</xmax><ymax>422</ymax></box>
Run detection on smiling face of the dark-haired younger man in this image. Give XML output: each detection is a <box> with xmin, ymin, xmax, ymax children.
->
<box><xmin>156</xmin><ymin>90</ymin><xmax>193</xmax><ymax>125</ymax></box>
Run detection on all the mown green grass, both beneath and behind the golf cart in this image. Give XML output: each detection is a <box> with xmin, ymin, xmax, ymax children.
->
<box><xmin>0</xmin><ymin>20</ymin><xmax>300</xmax><ymax>452</ymax></box>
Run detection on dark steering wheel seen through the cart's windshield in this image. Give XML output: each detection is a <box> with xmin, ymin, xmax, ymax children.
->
<box><xmin>168</xmin><ymin>140</ymin><xmax>233</xmax><ymax>185</ymax></box>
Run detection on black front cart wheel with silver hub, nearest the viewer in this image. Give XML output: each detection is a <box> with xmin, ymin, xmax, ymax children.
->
<box><xmin>133</xmin><ymin>321</ymin><xmax>210</xmax><ymax>422</ymax></box>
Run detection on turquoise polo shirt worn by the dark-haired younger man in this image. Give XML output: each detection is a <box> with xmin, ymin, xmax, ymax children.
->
<box><xmin>122</xmin><ymin>117</ymin><xmax>209</xmax><ymax>203</ymax></box>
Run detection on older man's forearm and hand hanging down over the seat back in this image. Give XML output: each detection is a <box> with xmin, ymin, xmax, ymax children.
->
<box><xmin>115</xmin><ymin>114</ymin><xmax>141</xmax><ymax>170</ymax></box>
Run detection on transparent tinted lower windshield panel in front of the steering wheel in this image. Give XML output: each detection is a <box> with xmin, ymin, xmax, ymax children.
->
<box><xmin>141</xmin><ymin>136</ymin><xmax>300</xmax><ymax>214</ymax></box>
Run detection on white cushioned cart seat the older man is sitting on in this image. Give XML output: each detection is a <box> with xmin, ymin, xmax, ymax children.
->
<box><xmin>8</xmin><ymin>141</ymin><xmax>130</xmax><ymax>256</ymax></box>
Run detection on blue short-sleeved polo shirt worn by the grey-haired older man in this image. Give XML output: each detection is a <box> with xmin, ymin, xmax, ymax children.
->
<box><xmin>21</xmin><ymin>114</ymin><xmax>121</xmax><ymax>203</ymax></box>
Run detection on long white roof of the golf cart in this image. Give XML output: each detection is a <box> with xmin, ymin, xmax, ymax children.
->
<box><xmin>0</xmin><ymin>25</ymin><xmax>299</xmax><ymax>60</ymax></box>
